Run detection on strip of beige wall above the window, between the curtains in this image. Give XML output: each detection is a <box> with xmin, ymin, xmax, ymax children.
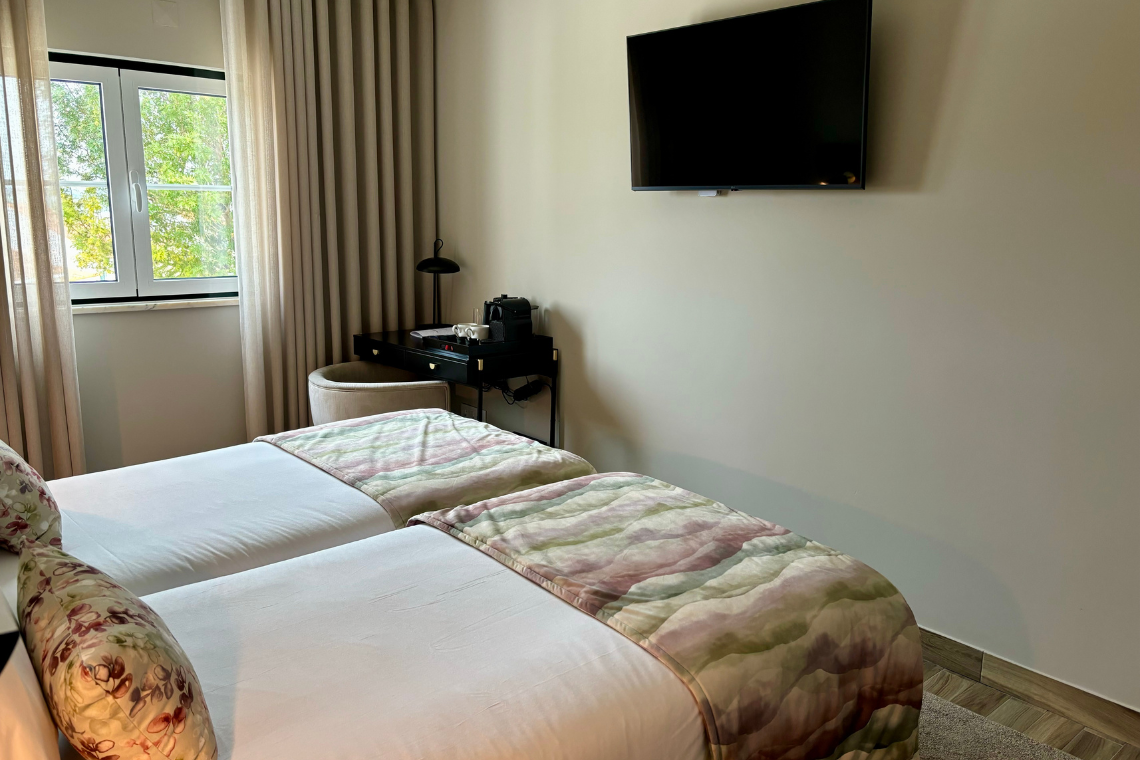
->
<box><xmin>43</xmin><ymin>0</ymin><xmax>223</xmax><ymax>68</ymax></box>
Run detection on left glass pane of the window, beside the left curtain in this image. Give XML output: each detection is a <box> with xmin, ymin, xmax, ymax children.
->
<box><xmin>51</xmin><ymin>81</ymin><xmax>115</xmax><ymax>283</ymax></box>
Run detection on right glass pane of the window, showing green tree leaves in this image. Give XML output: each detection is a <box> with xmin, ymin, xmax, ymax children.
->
<box><xmin>139</xmin><ymin>89</ymin><xmax>237</xmax><ymax>279</ymax></box>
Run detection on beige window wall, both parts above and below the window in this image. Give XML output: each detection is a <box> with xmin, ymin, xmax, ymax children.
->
<box><xmin>44</xmin><ymin>0</ymin><xmax>246</xmax><ymax>472</ymax></box>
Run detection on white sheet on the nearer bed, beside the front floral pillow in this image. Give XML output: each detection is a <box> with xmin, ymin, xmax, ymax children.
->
<box><xmin>133</xmin><ymin>525</ymin><xmax>706</xmax><ymax>760</ymax></box>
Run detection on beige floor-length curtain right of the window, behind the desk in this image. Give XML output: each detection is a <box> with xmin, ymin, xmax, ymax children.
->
<box><xmin>221</xmin><ymin>0</ymin><xmax>435</xmax><ymax>438</ymax></box>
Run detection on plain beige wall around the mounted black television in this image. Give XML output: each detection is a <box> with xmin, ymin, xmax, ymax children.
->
<box><xmin>437</xmin><ymin>0</ymin><xmax>1140</xmax><ymax>708</ymax></box>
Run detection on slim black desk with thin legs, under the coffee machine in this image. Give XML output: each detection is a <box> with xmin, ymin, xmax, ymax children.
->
<box><xmin>352</xmin><ymin>330</ymin><xmax>559</xmax><ymax>447</ymax></box>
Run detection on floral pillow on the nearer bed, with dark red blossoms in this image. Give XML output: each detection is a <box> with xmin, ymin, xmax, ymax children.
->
<box><xmin>18</xmin><ymin>544</ymin><xmax>218</xmax><ymax>760</ymax></box>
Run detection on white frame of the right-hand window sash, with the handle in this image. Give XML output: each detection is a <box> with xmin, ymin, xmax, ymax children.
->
<box><xmin>119</xmin><ymin>68</ymin><xmax>237</xmax><ymax>295</ymax></box>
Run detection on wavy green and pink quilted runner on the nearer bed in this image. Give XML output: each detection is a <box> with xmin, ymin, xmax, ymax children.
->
<box><xmin>412</xmin><ymin>473</ymin><xmax>922</xmax><ymax>760</ymax></box>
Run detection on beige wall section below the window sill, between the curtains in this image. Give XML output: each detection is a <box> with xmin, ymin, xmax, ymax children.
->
<box><xmin>75</xmin><ymin>305</ymin><xmax>246</xmax><ymax>472</ymax></box>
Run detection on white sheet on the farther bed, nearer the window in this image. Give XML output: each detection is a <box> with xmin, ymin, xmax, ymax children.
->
<box><xmin>21</xmin><ymin>443</ymin><xmax>393</xmax><ymax>596</ymax></box>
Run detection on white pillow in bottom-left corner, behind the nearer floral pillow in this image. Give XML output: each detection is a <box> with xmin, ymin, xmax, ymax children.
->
<box><xmin>0</xmin><ymin>597</ymin><xmax>59</xmax><ymax>760</ymax></box>
